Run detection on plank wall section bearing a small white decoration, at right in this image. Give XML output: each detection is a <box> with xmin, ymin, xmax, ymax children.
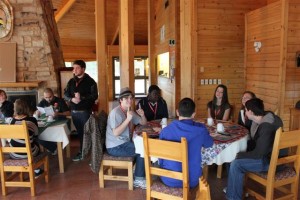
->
<box><xmin>245</xmin><ymin>1</ymin><xmax>281</xmax><ymax>111</ymax></box>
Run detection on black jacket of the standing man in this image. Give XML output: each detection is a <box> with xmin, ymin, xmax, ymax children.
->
<box><xmin>64</xmin><ymin>74</ymin><xmax>98</xmax><ymax>111</ymax></box>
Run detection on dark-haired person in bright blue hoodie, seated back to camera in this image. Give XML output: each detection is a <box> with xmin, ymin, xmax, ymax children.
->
<box><xmin>159</xmin><ymin>98</ymin><xmax>213</xmax><ymax>188</ymax></box>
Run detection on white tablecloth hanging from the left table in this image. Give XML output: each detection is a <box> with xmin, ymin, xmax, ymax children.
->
<box><xmin>39</xmin><ymin>123</ymin><xmax>70</xmax><ymax>148</ymax></box>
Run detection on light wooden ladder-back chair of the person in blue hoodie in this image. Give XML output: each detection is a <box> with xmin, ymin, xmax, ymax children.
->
<box><xmin>143</xmin><ymin>132</ymin><xmax>189</xmax><ymax>199</ymax></box>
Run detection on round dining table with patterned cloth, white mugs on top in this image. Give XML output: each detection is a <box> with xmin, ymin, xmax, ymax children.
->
<box><xmin>133</xmin><ymin>119</ymin><xmax>249</xmax><ymax>178</ymax></box>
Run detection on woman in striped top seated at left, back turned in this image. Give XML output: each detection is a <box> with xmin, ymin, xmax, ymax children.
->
<box><xmin>9</xmin><ymin>99</ymin><xmax>43</xmax><ymax>177</ymax></box>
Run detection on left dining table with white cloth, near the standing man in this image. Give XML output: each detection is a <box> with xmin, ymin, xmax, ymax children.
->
<box><xmin>38</xmin><ymin>118</ymin><xmax>71</xmax><ymax>173</ymax></box>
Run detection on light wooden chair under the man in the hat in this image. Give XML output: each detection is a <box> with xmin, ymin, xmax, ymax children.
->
<box><xmin>99</xmin><ymin>153</ymin><xmax>133</xmax><ymax>190</ymax></box>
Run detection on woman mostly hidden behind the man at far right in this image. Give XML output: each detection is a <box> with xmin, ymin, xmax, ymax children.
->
<box><xmin>238</xmin><ymin>91</ymin><xmax>256</xmax><ymax>130</ymax></box>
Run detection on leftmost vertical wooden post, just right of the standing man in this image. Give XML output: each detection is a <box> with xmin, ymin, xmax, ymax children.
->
<box><xmin>95</xmin><ymin>0</ymin><xmax>108</xmax><ymax>112</ymax></box>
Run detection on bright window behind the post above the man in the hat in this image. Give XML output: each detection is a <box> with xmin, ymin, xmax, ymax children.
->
<box><xmin>113</xmin><ymin>57</ymin><xmax>149</xmax><ymax>98</ymax></box>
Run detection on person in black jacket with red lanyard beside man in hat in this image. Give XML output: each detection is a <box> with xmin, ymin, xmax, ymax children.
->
<box><xmin>137</xmin><ymin>85</ymin><xmax>169</xmax><ymax>121</ymax></box>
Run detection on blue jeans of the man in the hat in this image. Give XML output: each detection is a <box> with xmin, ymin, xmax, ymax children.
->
<box><xmin>107</xmin><ymin>142</ymin><xmax>145</xmax><ymax>180</ymax></box>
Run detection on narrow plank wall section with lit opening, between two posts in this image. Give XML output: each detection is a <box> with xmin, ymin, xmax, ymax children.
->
<box><xmin>154</xmin><ymin>0</ymin><xmax>180</xmax><ymax>117</ymax></box>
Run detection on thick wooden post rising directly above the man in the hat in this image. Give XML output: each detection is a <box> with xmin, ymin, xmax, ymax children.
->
<box><xmin>119</xmin><ymin>0</ymin><xmax>134</xmax><ymax>91</ymax></box>
